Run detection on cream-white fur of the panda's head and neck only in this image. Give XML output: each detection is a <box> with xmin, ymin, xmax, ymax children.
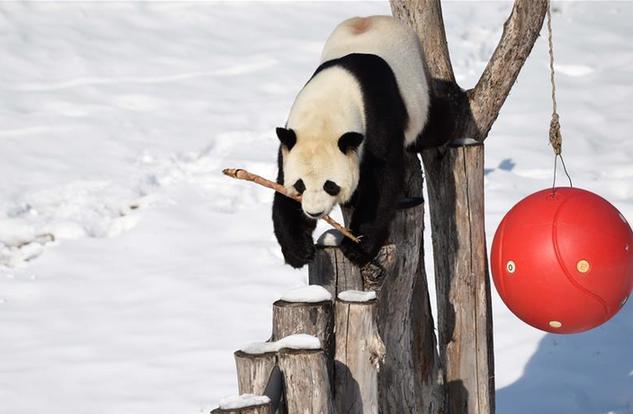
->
<box><xmin>282</xmin><ymin>67</ymin><xmax>365</xmax><ymax>217</ymax></box>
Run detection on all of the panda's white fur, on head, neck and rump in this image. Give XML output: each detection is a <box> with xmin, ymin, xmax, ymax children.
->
<box><xmin>282</xmin><ymin>16</ymin><xmax>429</xmax><ymax>217</ymax></box>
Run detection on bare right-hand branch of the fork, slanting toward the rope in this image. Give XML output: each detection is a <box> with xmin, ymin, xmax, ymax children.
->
<box><xmin>469</xmin><ymin>0</ymin><xmax>548</xmax><ymax>139</ymax></box>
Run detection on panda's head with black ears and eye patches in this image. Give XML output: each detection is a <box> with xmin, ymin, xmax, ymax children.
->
<box><xmin>277</xmin><ymin>128</ymin><xmax>363</xmax><ymax>219</ymax></box>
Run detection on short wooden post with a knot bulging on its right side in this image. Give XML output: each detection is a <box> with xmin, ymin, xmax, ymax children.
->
<box><xmin>334</xmin><ymin>299</ymin><xmax>385</xmax><ymax>414</ymax></box>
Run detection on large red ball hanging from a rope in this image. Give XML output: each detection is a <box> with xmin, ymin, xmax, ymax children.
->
<box><xmin>491</xmin><ymin>188</ymin><xmax>633</xmax><ymax>333</ymax></box>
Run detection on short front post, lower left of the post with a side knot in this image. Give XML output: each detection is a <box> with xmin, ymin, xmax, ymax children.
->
<box><xmin>278</xmin><ymin>349</ymin><xmax>334</xmax><ymax>414</ymax></box>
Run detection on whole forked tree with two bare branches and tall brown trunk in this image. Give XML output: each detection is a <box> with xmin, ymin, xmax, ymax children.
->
<box><xmin>391</xmin><ymin>0</ymin><xmax>548</xmax><ymax>414</ymax></box>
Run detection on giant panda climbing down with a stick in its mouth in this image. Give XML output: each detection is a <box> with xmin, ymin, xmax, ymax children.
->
<box><xmin>272</xmin><ymin>16</ymin><xmax>429</xmax><ymax>268</ymax></box>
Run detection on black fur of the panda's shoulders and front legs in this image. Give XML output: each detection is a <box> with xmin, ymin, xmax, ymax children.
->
<box><xmin>273</xmin><ymin>53</ymin><xmax>408</xmax><ymax>267</ymax></box>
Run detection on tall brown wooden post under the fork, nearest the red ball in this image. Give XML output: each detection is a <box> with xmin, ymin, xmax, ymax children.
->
<box><xmin>424</xmin><ymin>144</ymin><xmax>494</xmax><ymax>413</ymax></box>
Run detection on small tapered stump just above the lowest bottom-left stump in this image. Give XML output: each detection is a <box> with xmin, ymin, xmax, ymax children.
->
<box><xmin>233</xmin><ymin>350</ymin><xmax>277</xmax><ymax>395</ymax></box>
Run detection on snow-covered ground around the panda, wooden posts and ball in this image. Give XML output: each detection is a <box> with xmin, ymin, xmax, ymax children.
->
<box><xmin>0</xmin><ymin>2</ymin><xmax>633</xmax><ymax>414</ymax></box>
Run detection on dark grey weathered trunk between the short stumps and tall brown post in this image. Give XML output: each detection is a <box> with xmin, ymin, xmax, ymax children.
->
<box><xmin>378</xmin><ymin>154</ymin><xmax>444</xmax><ymax>413</ymax></box>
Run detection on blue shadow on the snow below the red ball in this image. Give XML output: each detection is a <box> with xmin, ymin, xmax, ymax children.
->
<box><xmin>497</xmin><ymin>303</ymin><xmax>633</xmax><ymax>414</ymax></box>
